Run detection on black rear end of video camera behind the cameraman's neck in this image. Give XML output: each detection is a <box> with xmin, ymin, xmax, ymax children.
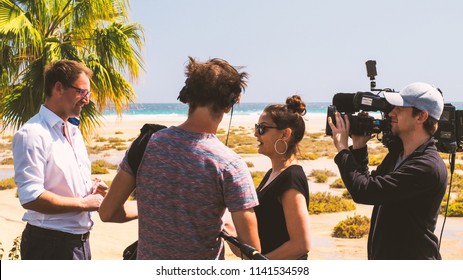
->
<box><xmin>434</xmin><ymin>103</ymin><xmax>463</xmax><ymax>154</ymax></box>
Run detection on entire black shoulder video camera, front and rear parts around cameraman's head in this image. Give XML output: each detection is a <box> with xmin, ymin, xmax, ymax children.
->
<box><xmin>325</xmin><ymin>60</ymin><xmax>463</xmax><ymax>154</ymax></box>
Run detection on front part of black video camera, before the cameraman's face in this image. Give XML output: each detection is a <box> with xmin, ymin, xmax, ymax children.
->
<box><xmin>325</xmin><ymin>60</ymin><xmax>395</xmax><ymax>141</ymax></box>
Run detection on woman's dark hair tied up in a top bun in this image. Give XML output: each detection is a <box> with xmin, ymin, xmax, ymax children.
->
<box><xmin>264</xmin><ymin>95</ymin><xmax>307</xmax><ymax>157</ymax></box>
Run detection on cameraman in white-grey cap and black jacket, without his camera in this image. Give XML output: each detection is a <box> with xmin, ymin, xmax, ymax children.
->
<box><xmin>328</xmin><ymin>83</ymin><xmax>447</xmax><ymax>259</ymax></box>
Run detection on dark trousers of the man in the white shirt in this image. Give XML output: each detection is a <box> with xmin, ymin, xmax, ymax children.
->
<box><xmin>21</xmin><ymin>224</ymin><xmax>92</xmax><ymax>260</ymax></box>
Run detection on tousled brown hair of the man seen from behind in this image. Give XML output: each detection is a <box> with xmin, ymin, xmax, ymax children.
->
<box><xmin>177</xmin><ymin>57</ymin><xmax>248</xmax><ymax>118</ymax></box>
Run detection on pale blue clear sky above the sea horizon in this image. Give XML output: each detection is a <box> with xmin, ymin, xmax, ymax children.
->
<box><xmin>130</xmin><ymin>0</ymin><xmax>463</xmax><ymax>103</ymax></box>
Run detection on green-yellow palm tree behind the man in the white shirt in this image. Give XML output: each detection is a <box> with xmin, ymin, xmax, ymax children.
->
<box><xmin>0</xmin><ymin>0</ymin><xmax>144</xmax><ymax>136</ymax></box>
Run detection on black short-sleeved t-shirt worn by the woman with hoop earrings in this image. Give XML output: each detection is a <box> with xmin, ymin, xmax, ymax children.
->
<box><xmin>254</xmin><ymin>165</ymin><xmax>309</xmax><ymax>258</ymax></box>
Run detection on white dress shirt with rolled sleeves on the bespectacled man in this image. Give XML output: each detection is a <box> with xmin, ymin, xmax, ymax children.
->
<box><xmin>13</xmin><ymin>105</ymin><xmax>93</xmax><ymax>234</ymax></box>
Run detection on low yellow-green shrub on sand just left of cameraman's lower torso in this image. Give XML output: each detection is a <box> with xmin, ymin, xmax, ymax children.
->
<box><xmin>332</xmin><ymin>215</ymin><xmax>370</xmax><ymax>239</ymax></box>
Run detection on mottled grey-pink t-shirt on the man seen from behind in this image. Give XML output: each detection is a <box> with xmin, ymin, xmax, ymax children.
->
<box><xmin>121</xmin><ymin>127</ymin><xmax>258</xmax><ymax>259</ymax></box>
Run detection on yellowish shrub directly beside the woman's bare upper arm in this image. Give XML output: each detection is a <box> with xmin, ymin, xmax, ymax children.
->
<box><xmin>309</xmin><ymin>192</ymin><xmax>355</xmax><ymax>215</ymax></box>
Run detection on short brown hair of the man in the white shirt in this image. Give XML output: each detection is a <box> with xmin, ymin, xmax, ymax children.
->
<box><xmin>45</xmin><ymin>59</ymin><xmax>93</xmax><ymax>97</ymax></box>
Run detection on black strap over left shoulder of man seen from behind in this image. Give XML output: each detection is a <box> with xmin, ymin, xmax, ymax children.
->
<box><xmin>127</xmin><ymin>123</ymin><xmax>167</xmax><ymax>177</ymax></box>
